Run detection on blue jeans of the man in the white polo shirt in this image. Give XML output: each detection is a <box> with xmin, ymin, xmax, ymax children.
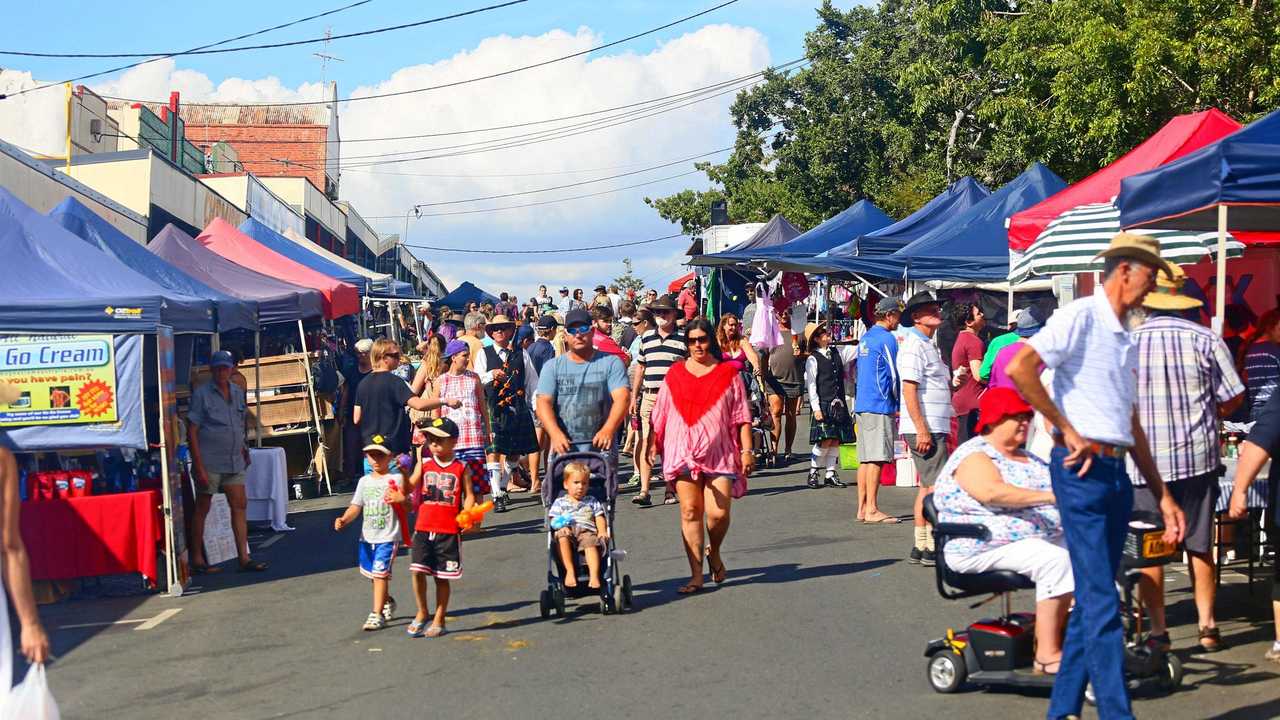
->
<box><xmin>1048</xmin><ymin>447</ymin><xmax>1133</xmax><ymax>720</ymax></box>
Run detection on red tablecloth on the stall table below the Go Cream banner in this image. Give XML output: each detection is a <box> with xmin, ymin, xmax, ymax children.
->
<box><xmin>22</xmin><ymin>491</ymin><xmax>164</xmax><ymax>584</ymax></box>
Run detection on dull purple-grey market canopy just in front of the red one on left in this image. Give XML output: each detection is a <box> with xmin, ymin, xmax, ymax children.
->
<box><xmin>147</xmin><ymin>224</ymin><xmax>324</xmax><ymax>325</ymax></box>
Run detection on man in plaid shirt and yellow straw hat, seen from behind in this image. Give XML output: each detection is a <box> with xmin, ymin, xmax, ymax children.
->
<box><xmin>1129</xmin><ymin>265</ymin><xmax>1244</xmax><ymax>652</ymax></box>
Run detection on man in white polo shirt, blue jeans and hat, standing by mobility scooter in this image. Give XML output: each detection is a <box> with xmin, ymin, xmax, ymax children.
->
<box><xmin>1007</xmin><ymin>233</ymin><xmax>1185</xmax><ymax>719</ymax></box>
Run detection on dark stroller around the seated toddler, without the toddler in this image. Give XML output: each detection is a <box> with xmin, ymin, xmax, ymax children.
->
<box><xmin>538</xmin><ymin>452</ymin><xmax>632</xmax><ymax>619</ymax></box>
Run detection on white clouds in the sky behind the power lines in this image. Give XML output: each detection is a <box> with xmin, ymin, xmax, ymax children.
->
<box><xmin>10</xmin><ymin>24</ymin><xmax>769</xmax><ymax>297</ymax></box>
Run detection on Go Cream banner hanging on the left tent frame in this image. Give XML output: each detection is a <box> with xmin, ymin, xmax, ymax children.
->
<box><xmin>0</xmin><ymin>334</ymin><xmax>116</xmax><ymax>427</ymax></box>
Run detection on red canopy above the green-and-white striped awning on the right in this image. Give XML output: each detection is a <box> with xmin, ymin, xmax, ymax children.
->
<box><xmin>1009</xmin><ymin>108</ymin><xmax>1240</xmax><ymax>251</ymax></box>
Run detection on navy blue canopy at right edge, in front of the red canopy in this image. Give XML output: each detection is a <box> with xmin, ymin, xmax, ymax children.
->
<box><xmin>1116</xmin><ymin>110</ymin><xmax>1280</xmax><ymax>232</ymax></box>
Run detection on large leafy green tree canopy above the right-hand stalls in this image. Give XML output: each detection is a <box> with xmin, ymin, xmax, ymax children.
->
<box><xmin>645</xmin><ymin>0</ymin><xmax>1280</xmax><ymax>234</ymax></box>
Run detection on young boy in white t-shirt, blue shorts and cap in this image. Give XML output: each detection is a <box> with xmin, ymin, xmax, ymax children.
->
<box><xmin>333</xmin><ymin>437</ymin><xmax>404</xmax><ymax>630</ymax></box>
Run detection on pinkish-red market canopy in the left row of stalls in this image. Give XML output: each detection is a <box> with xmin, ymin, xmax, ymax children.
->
<box><xmin>196</xmin><ymin>218</ymin><xmax>360</xmax><ymax>320</ymax></box>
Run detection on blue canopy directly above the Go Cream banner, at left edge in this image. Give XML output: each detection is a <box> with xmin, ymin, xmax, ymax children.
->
<box><xmin>0</xmin><ymin>183</ymin><xmax>214</xmax><ymax>334</ymax></box>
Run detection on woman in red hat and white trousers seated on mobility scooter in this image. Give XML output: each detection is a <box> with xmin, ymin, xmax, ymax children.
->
<box><xmin>933</xmin><ymin>387</ymin><xmax>1075</xmax><ymax>674</ymax></box>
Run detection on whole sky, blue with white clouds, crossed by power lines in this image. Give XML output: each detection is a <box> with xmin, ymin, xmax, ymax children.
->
<box><xmin>0</xmin><ymin>0</ymin><xmax>852</xmax><ymax>296</ymax></box>
